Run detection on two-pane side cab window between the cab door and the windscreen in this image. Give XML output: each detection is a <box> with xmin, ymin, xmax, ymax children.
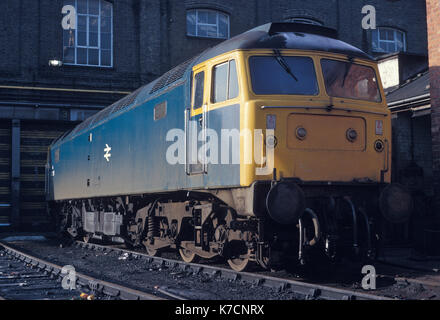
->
<box><xmin>211</xmin><ymin>60</ymin><xmax>239</xmax><ymax>103</ymax></box>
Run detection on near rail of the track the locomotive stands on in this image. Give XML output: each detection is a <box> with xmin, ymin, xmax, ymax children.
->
<box><xmin>74</xmin><ymin>241</ymin><xmax>392</xmax><ymax>300</ymax></box>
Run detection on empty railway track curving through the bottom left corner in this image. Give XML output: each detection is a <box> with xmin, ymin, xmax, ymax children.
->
<box><xmin>0</xmin><ymin>242</ymin><xmax>166</xmax><ymax>300</ymax></box>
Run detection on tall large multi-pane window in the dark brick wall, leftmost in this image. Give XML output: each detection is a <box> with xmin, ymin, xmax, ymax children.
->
<box><xmin>63</xmin><ymin>0</ymin><xmax>113</xmax><ymax>67</ymax></box>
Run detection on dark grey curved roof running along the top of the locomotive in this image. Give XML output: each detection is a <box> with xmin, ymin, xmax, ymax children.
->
<box><xmin>54</xmin><ymin>23</ymin><xmax>373</xmax><ymax>144</ymax></box>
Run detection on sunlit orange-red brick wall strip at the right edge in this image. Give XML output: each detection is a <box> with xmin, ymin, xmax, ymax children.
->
<box><xmin>426</xmin><ymin>0</ymin><xmax>440</xmax><ymax>212</ymax></box>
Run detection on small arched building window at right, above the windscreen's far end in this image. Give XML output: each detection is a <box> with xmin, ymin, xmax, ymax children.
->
<box><xmin>373</xmin><ymin>28</ymin><xmax>406</xmax><ymax>52</ymax></box>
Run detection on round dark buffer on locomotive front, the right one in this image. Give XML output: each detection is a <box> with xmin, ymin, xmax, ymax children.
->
<box><xmin>379</xmin><ymin>183</ymin><xmax>414</xmax><ymax>223</ymax></box>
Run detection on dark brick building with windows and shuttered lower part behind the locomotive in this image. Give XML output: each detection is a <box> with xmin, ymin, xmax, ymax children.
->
<box><xmin>0</xmin><ymin>0</ymin><xmax>428</xmax><ymax>229</ymax></box>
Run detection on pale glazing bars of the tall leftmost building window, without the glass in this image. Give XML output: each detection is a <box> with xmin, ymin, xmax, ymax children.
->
<box><xmin>63</xmin><ymin>0</ymin><xmax>114</xmax><ymax>68</ymax></box>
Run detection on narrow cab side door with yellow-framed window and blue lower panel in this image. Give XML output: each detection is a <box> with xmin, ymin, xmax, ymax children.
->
<box><xmin>185</xmin><ymin>67</ymin><xmax>208</xmax><ymax>175</ymax></box>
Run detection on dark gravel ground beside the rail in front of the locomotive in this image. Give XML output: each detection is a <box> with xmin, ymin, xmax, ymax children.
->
<box><xmin>4</xmin><ymin>239</ymin><xmax>440</xmax><ymax>300</ymax></box>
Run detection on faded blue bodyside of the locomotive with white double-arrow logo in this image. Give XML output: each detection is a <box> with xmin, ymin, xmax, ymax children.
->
<box><xmin>49</xmin><ymin>64</ymin><xmax>240</xmax><ymax>200</ymax></box>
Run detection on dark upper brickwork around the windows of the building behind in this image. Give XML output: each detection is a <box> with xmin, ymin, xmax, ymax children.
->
<box><xmin>0</xmin><ymin>0</ymin><xmax>435</xmax><ymax>95</ymax></box>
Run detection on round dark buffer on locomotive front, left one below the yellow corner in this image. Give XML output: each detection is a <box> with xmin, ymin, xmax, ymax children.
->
<box><xmin>266</xmin><ymin>181</ymin><xmax>305</xmax><ymax>225</ymax></box>
